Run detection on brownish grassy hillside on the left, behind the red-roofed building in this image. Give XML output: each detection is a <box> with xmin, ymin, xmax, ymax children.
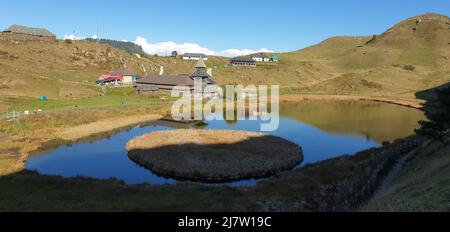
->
<box><xmin>0</xmin><ymin>41</ymin><xmax>158</xmax><ymax>98</ymax></box>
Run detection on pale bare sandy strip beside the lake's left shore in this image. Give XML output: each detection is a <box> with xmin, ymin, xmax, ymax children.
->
<box><xmin>57</xmin><ymin>114</ymin><xmax>162</xmax><ymax>141</ymax></box>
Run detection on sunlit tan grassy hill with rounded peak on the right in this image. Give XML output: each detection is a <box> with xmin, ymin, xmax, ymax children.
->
<box><xmin>289</xmin><ymin>14</ymin><xmax>450</xmax><ymax>97</ymax></box>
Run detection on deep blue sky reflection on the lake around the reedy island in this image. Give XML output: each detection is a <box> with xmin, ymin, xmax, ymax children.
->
<box><xmin>26</xmin><ymin>118</ymin><xmax>378</xmax><ymax>186</ymax></box>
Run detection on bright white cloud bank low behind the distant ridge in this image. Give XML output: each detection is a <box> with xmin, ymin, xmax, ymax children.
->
<box><xmin>134</xmin><ymin>36</ymin><xmax>273</xmax><ymax>57</ymax></box>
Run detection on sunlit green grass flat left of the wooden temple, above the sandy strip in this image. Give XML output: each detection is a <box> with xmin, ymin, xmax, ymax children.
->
<box><xmin>0</xmin><ymin>88</ymin><xmax>174</xmax><ymax>135</ymax></box>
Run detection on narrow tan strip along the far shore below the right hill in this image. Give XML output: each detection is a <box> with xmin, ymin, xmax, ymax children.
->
<box><xmin>280</xmin><ymin>95</ymin><xmax>425</xmax><ymax>110</ymax></box>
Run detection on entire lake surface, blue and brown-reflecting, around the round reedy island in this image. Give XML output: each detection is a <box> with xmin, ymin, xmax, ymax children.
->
<box><xmin>25</xmin><ymin>101</ymin><xmax>425</xmax><ymax>186</ymax></box>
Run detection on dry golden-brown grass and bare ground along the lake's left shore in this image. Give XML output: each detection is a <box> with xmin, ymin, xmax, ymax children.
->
<box><xmin>0</xmin><ymin>107</ymin><xmax>166</xmax><ymax>176</ymax></box>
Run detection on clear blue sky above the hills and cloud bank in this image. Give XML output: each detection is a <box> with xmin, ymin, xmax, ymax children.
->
<box><xmin>0</xmin><ymin>0</ymin><xmax>450</xmax><ymax>55</ymax></box>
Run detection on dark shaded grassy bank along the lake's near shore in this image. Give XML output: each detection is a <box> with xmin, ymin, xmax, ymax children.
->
<box><xmin>0</xmin><ymin>136</ymin><xmax>422</xmax><ymax>212</ymax></box>
